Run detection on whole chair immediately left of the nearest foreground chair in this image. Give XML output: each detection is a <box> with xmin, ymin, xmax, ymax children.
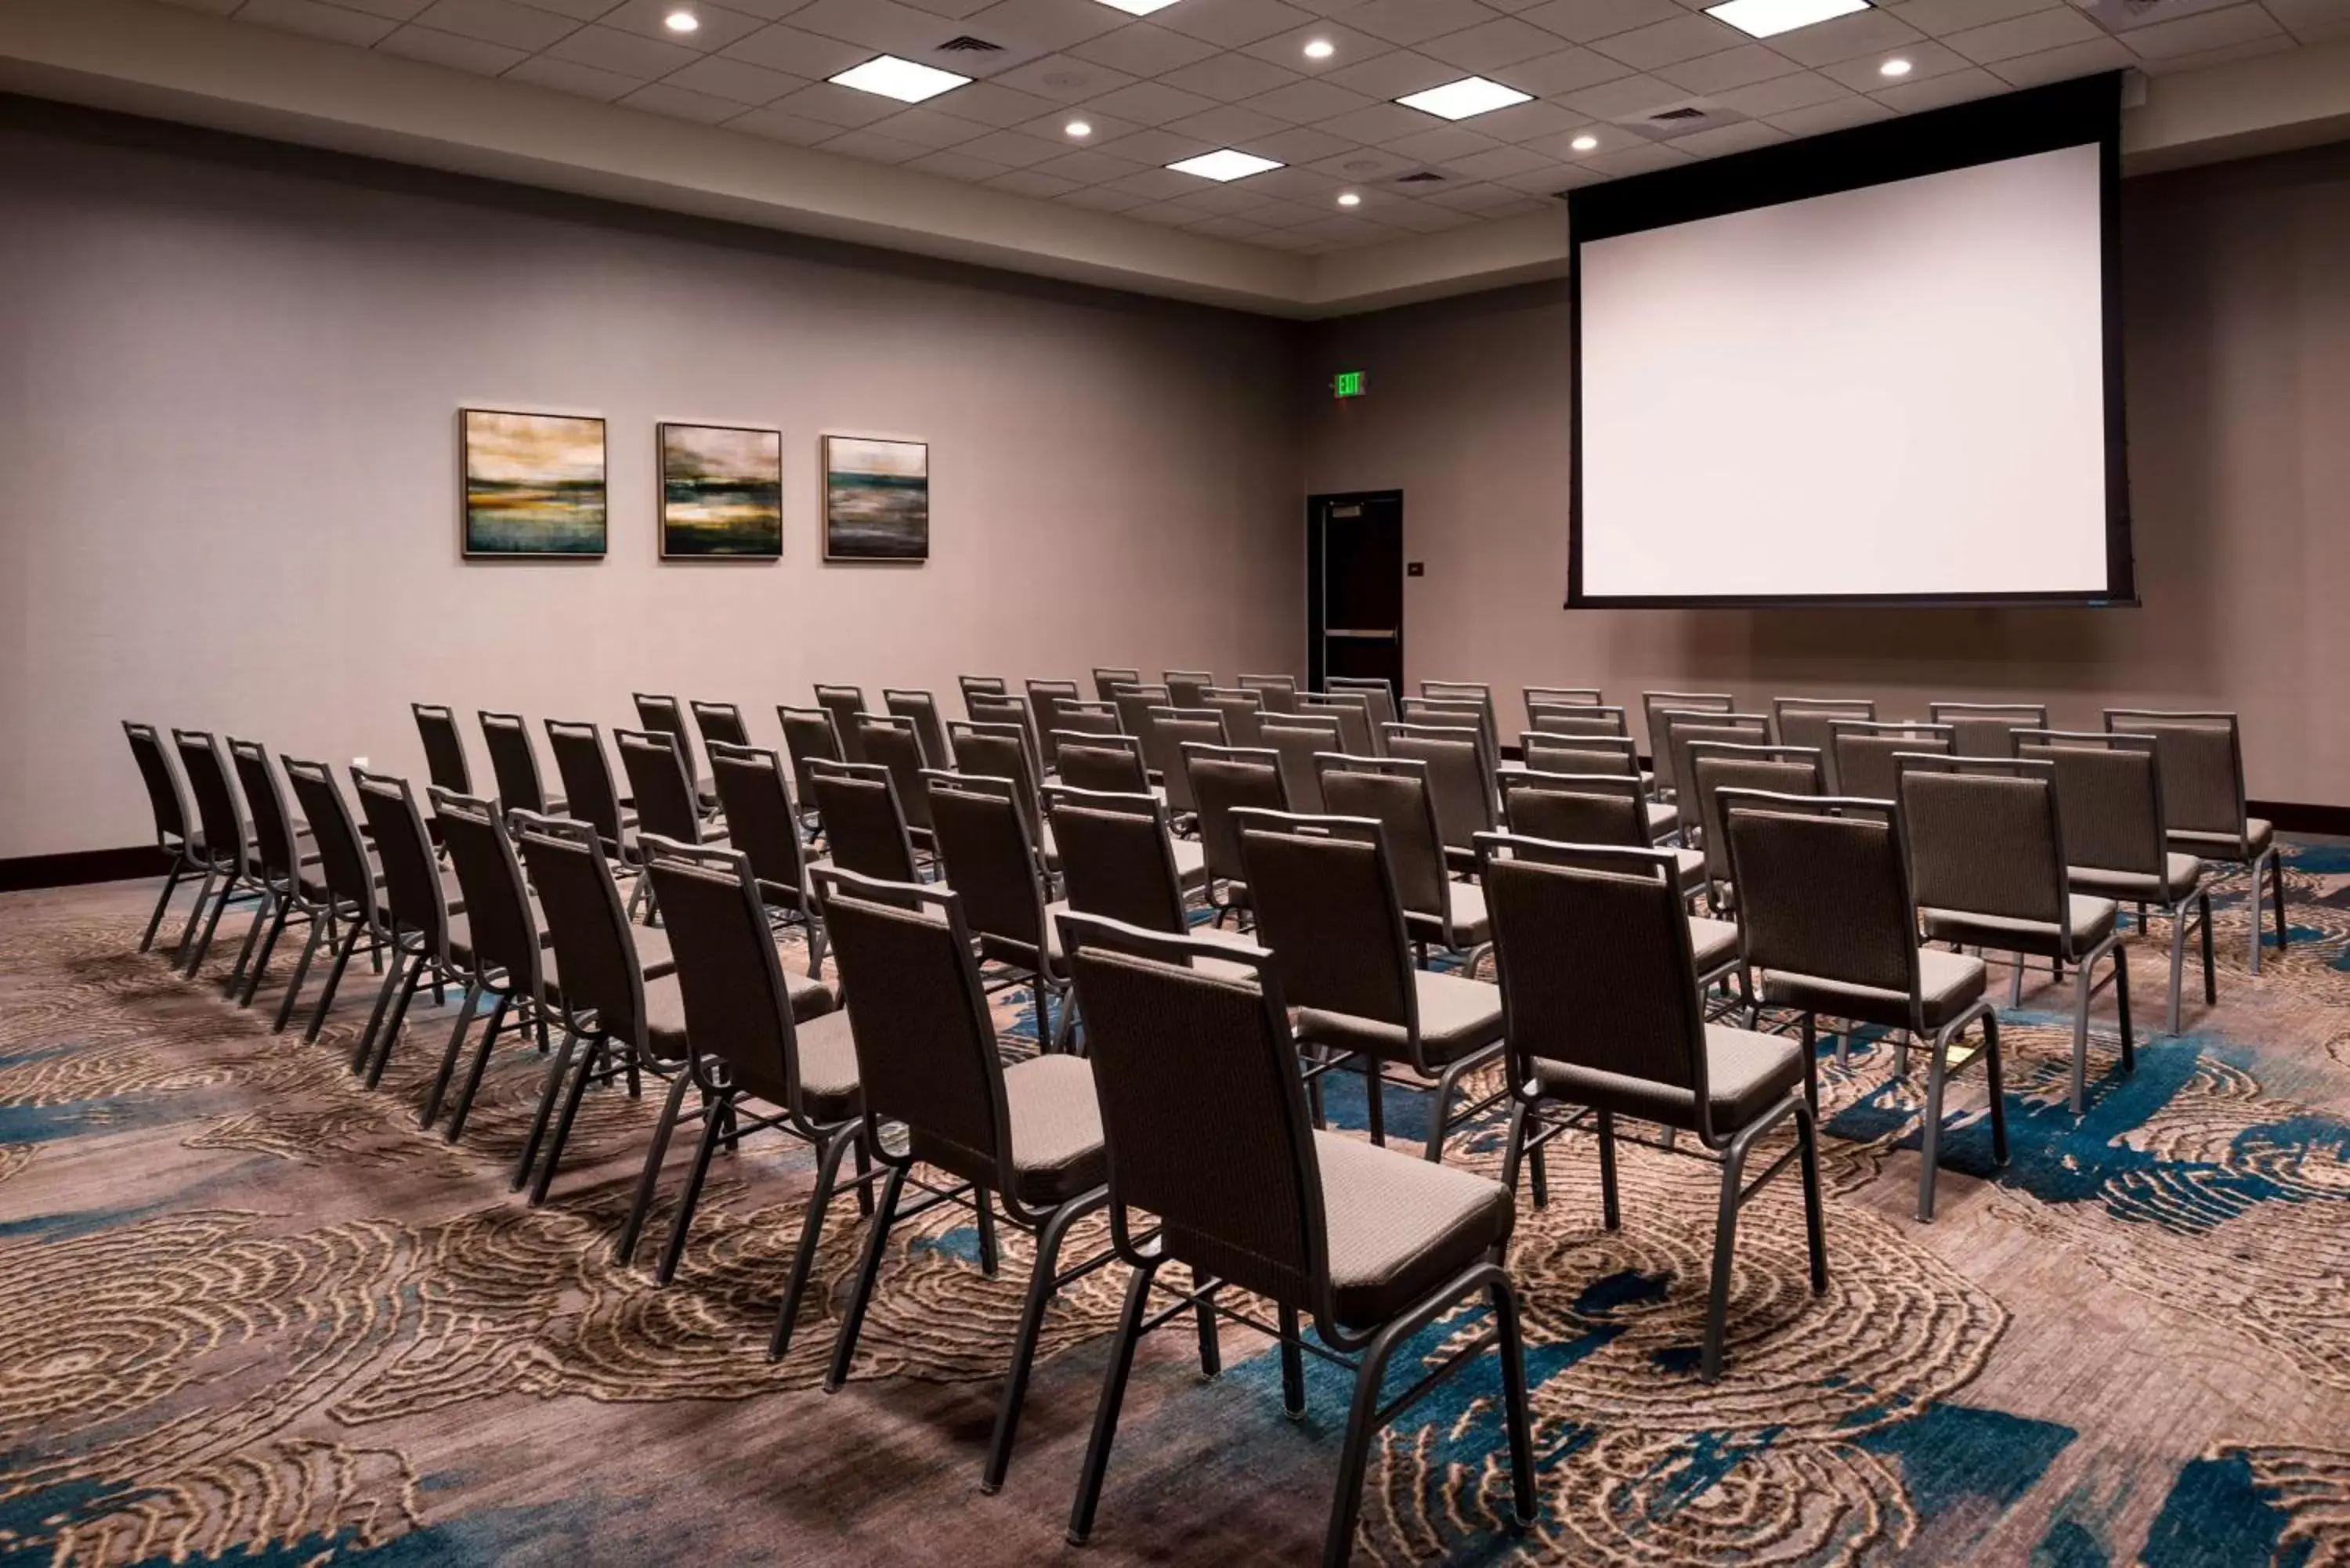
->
<box><xmin>813</xmin><ymin>868</ymin><xmax>1112</xmax><ymax>1493</ymax></box>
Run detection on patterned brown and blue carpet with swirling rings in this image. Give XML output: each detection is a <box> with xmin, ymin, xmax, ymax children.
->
<box><xmin>0</xmin><ymin>844</ymin><xmax>2350</xmax><ymax>1568</ymax></box>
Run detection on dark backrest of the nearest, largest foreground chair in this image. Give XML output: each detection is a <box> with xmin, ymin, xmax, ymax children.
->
<box><xmin>1065</xmin><ymin>917</ymin><xmax>1328</xmax><ymax>1312</ymax></box>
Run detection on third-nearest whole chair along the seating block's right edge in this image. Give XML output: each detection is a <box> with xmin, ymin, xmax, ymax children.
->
<box><xmin>1716</xmin><ymin>790</ymin><xmax>2007</xmax><ymax>1223</ymax></box>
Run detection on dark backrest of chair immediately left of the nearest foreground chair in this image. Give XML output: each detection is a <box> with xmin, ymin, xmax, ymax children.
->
<box><xmin>808</xmin><ymin>865</ymin><xmax>1010</xmax><ymax>1192</ymax></box>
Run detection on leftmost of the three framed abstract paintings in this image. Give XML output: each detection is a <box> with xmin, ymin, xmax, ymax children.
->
<box><xmin>461</xmin><ymin>409</ymin><xmax>604</xmax><ymax>559</ymax></box>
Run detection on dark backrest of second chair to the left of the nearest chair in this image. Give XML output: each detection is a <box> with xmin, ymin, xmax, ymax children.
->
<box><xmin>644</xmin><ymin>835</ymin><xmax>799</xmax><ymax>1115</ymax></box>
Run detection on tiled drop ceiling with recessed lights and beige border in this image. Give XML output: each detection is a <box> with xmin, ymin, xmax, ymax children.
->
<box><xmin>0</xmin><ymin>0</ymin><xmax>2350</xmax><ymax>315</ymax></box>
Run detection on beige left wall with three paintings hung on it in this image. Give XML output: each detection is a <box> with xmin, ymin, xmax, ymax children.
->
<box><xmin>0</xmin><ymin>101</ymin><xmax>1302</xmax><ymax>856</ymax></box>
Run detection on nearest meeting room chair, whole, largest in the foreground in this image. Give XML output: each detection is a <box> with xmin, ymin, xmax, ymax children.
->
<box><xmin>1065</xmin><ymin>915</ymin><xmax>1539</xmax><ymax>1563</ymax></box>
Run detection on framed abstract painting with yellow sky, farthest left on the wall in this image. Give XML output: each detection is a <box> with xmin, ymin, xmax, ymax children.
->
<box><xmin>456</xmin><ymin>404</ymin><xmax>611</xmax><ymax>562</ymax></box>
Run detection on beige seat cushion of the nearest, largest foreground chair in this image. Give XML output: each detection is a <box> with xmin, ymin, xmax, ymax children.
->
<box><xmin>1314</xmin><ymin>1133</ymin><xmax>1513</xmax><ymax>1326</ymax></box>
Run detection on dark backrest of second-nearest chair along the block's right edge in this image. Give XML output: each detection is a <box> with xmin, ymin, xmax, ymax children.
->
<box><xmin>1478</xmin><ymin>835</ymin><xmax>1713</xmax><ymax>1143</ymax></box>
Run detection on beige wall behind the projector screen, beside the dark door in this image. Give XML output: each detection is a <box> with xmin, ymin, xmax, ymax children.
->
<box><xmin>1302</xmin><ymin>148</ymin><xmax>2350</xmax><ymax>804</ymax></box>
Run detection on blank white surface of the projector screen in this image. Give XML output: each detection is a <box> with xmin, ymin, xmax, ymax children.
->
<box><xmin>1579</xmin><ymin>143</ymin><xmax>2108</xmax><ymax>599</ymax></box>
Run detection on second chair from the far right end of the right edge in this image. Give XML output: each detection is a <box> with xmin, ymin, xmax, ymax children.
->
<box><xmin>2016</xmin><ymin>728</ymin><xmax>2218</xmax><ymax>1035</ymax></box>
